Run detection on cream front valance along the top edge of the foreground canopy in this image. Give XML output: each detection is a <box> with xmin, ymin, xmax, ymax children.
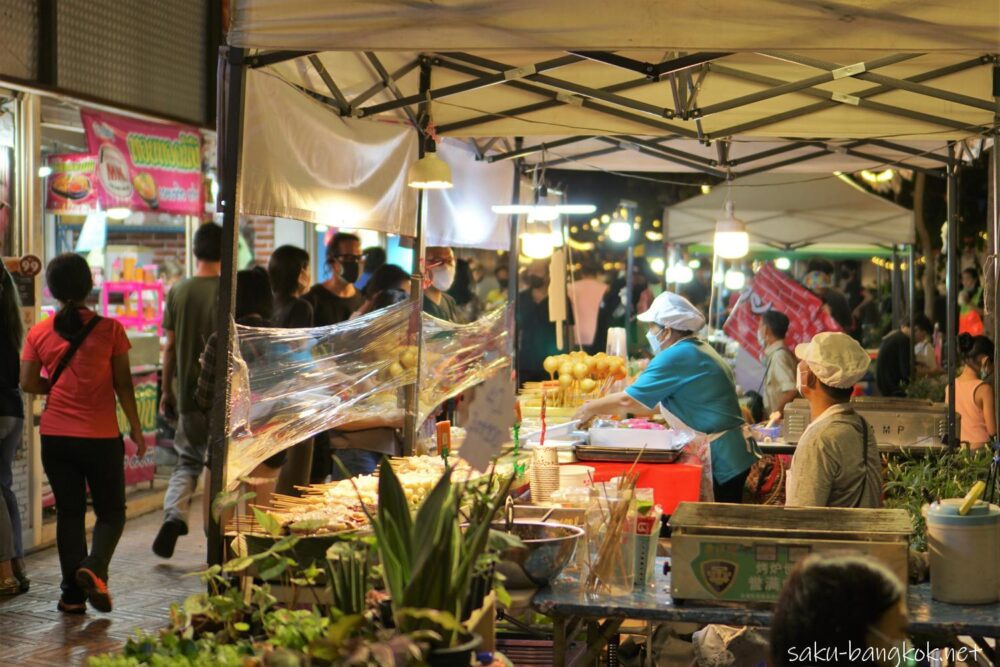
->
<box><xmin>229</xmin><ymin>0</ymin><xmax>1000</xmax><ymax>51</ymax></box>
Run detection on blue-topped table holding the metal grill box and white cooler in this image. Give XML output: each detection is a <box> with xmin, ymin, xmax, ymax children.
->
<box><xmin>532</xmin><ymin>558</ymin><xmax>1000</xmax><ymax>666</ymax></box>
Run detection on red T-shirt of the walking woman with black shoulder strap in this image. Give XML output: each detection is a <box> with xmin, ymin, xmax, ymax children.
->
<box><xmin>21</xmin><ymin>310</ymin><xmax>132</xmax><ymax>438</ymax></box>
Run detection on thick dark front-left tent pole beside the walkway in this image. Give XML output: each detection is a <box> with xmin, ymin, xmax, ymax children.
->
<box><xmin>202</xmin><ymin>47</ymin><xmax>246</xmax><ymax>565</ymax></box>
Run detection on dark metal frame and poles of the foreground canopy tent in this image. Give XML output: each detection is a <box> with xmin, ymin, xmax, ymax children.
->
<box><xmin>208</xmin><ymin>41</ymin><xmax>1000</xmax><ymax>563</ymax></box>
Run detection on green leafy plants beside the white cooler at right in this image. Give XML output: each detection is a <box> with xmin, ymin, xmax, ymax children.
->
<box><xmin>885</xmin><ymin>448</ymin><xmax>992</xmax><ymax>551</ymax></box>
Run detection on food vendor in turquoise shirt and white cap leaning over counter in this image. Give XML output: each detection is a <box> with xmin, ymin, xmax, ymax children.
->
<box><xmin>576</xmin><ymin>292</ymin><xmax>756</xmax><ymax>503</ymax></box>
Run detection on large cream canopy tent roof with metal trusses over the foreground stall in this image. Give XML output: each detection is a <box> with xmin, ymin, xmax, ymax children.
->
<box><xmin>199</xmin><ymin>0</ymin><xmax>1000</xmax><ymax>560</ymax></box>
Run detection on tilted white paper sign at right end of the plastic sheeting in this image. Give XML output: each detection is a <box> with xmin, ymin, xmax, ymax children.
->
<box><xmin>459</xmin><ymin>365</ymin><xmax>514</xmax><ymax>470</ymax></box>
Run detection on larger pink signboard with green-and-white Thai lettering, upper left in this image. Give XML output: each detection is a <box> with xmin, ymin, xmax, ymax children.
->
<box><xmin>80</xmin><ymin>110</ymin><xmax>205</xmax><ymax>216</ymax></box>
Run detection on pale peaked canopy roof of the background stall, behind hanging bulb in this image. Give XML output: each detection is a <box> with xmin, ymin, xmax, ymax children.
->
<box><xmin>664</xmin><ymin>174</ymin><xmax>915</xmax><ymax>252</ymax></box>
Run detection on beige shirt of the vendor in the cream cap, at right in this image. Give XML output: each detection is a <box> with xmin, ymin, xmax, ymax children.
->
<box><xmin>785</xmin><ymin>404</ymin><xmax>882</xmax><ymax>508</ymax></box>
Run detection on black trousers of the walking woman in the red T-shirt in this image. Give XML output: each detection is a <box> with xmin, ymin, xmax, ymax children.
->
<box><xmin>42</xmin><ymin>435</ymin><xmax>125</xmax><ymax>604</ymax></box>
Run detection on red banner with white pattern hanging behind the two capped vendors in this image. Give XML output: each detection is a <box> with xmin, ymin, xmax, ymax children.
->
<box><xmin>723</xmin><ymin>264</ymin><xmax>841</xmax><ymax>359</ymax></box>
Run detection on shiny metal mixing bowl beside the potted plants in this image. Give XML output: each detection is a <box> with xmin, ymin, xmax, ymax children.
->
<box><xmin>492</xmin><ymin>521</ymin><xmax>584</xmax><ymax>590</ymax></box>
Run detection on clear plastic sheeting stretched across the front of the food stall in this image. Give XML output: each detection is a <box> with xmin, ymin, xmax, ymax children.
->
<box><xmin>226</xmin><ymin>302</ymin><xmax>510</xmax><ymax>487</ymax></box>
